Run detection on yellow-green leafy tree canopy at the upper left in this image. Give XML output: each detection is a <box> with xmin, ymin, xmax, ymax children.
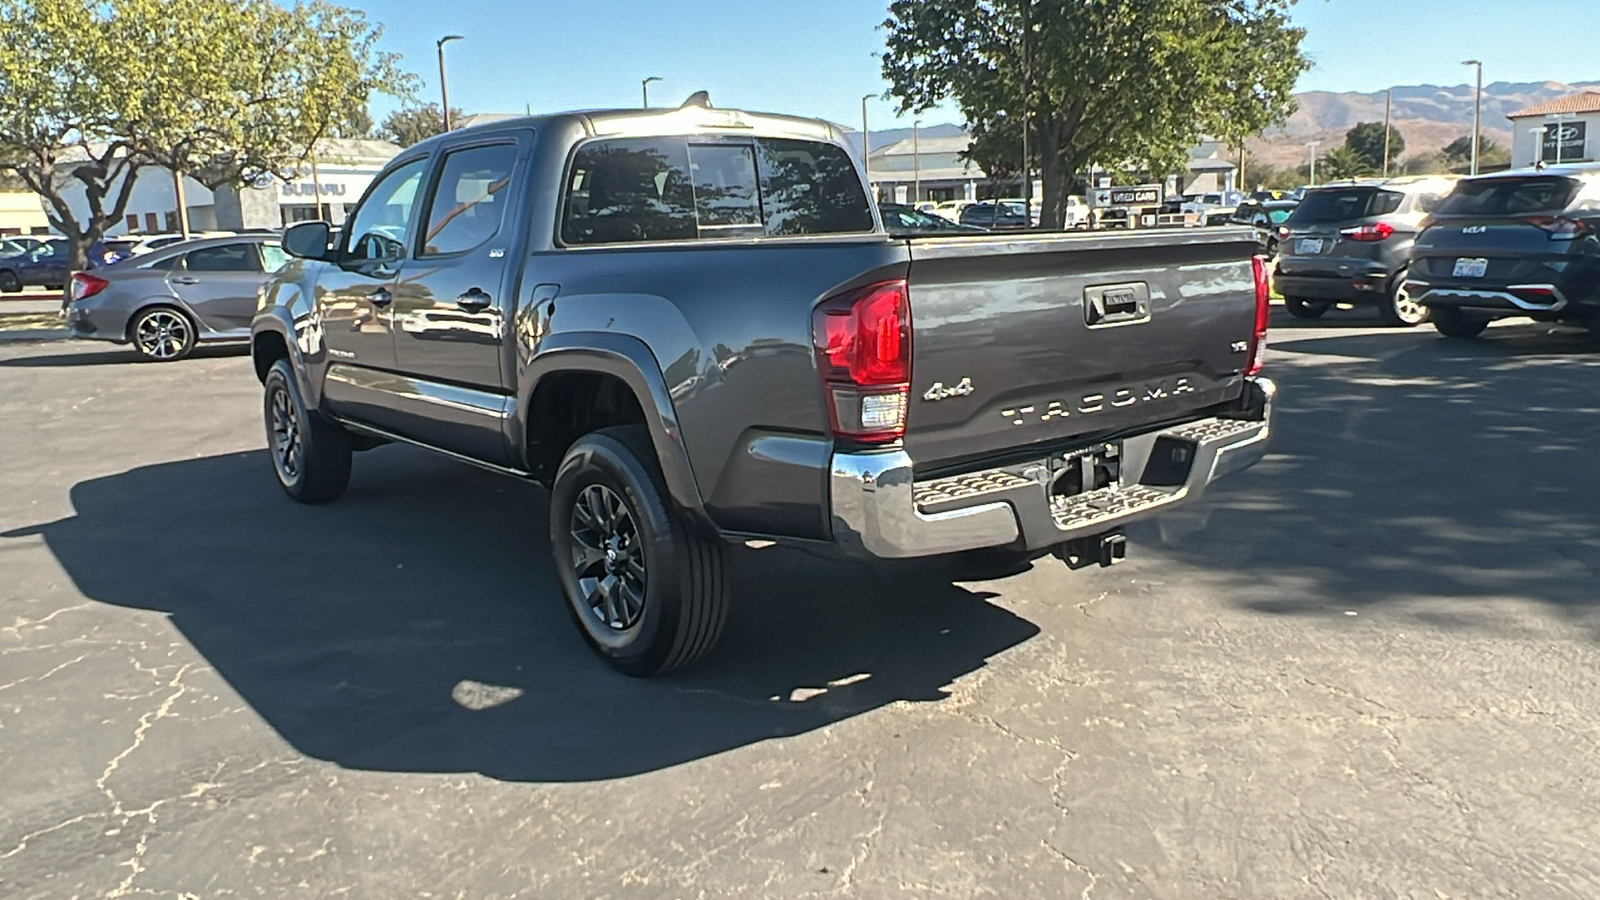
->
<box><xmin>0</xmin><ymin>0</ymin><xmax>413</xmax><ymax>262</ymax></box>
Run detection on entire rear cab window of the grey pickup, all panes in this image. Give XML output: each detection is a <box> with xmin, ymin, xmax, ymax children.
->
<box><xmin>560</xmin><ymin>138</ymin><xmax>874</xmax><ymax>245</ymax></box>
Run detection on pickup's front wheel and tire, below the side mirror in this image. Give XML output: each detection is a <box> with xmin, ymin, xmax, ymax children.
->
<box><xmin>262</xmin><ymin>359</ymin><xmax>350</xmax><ymax>503</ymax></box>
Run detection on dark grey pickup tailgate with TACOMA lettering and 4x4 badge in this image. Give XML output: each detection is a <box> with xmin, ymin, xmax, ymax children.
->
<box><xmin>906</xmin><ymin>229</ymin><xmax>1256</xmax><ymax>472</ymax></box>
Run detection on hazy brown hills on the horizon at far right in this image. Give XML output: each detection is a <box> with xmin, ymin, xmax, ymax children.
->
<box><xmin>1248</xmin><ymin>82</ymin><xmax>1600</xmax><ymax>167</ymax></box>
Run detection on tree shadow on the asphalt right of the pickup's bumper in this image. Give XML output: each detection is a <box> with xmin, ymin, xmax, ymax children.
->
<box><xmin>1147</xmin><ymin>318</ymin><xmax>1600</xmax><ymax>639</ymax></box>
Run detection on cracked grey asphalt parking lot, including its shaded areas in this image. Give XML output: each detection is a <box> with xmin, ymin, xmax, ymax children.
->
<box><xmin>0</xmin><ymin>312</ymin><xmax>1600</xmax><ymax>900</ymax></box>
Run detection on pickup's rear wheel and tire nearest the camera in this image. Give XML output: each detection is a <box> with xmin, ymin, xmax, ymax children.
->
<box><xmin>550</xmin><ymin>426</ymin><xmax>728</xmax><ymax>676</ymax></box>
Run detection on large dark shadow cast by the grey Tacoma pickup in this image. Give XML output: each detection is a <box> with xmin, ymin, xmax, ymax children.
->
<box><xmin>8</xmin><ymin>447</ymin><xmax>1038</xmax><ymax>781</ymax></box>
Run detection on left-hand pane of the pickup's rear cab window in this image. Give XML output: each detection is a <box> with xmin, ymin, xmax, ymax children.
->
<box><xmin>562</xmin><ymin>138</ymin><xmax>698</xmax><ymax>245</ymax></box>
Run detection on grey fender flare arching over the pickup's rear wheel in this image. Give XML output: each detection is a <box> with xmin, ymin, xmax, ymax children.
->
<box><xmin>517</xmin><ymin>331</ymin><xmax>710</xmax><ymax>524</ymax></box>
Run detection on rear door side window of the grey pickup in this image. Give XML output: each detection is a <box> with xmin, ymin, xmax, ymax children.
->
<box><xmin>419</xmin><ymin>144</ymin><xmax>517</xmax><ymax>256</ymax></box>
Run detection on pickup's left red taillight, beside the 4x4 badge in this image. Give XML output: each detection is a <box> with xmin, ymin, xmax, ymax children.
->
<box><xmin>811</xmin><ymin>280</ymin><xmax>910</xmax><ymax>444</ymax></box>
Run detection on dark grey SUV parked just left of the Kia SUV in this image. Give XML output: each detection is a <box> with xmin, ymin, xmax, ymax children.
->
<box><xmin>1277</xmin><ymin>176</ymin><xmax>1454</xmax><ymax>327</ymax></box>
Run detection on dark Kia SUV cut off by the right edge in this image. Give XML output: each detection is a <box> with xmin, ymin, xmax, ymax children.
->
<box><xmin>1410</xmin><ymin>165</ymin><xmax>1600</xmax><ymax>338</ymax></box>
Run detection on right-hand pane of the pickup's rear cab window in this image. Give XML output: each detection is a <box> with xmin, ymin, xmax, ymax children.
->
<box><xmin>755</xmin><ymin>138</ymin><xmax>872</xmax><ymax>235</ymax></box>
